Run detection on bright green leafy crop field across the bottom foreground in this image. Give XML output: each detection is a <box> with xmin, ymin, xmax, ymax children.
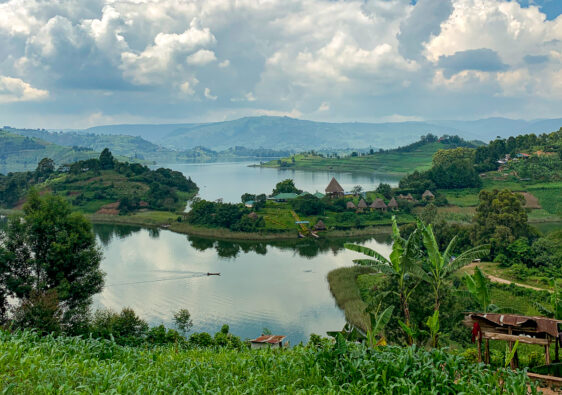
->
<box><xmin>0</xmin><ymin>332</ymin><xmax>537</xmax><ymax>394</ymax></box>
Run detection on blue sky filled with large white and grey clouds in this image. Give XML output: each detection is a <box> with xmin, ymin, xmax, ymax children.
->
<box><xmin>0</xmin><ymin>0</ymin><xmax>562</xmax><ymax>128</ymax></box>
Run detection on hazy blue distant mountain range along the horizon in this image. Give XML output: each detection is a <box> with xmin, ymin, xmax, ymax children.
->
<box><xmin>83</xmin><ymin>116</ymin><xmax>562</xmax><ymax>151</ymax></box>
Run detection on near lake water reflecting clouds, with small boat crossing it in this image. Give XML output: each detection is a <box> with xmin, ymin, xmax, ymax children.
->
<box><xmin>94</xmin><ymin>225</ymin><xmax>390</xmax><ymax>344</ymax></box>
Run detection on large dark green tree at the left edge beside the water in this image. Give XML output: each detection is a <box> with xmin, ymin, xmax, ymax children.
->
<box><xmin>0</xmin><ymin>190</ymin><xmax>104</xmax><ymax>332</ymax></box>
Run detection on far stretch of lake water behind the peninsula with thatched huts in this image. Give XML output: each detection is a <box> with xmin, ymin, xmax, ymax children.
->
<box><xmin>157</xmin><ymin>161</ymin><xmax>398</xmax><ymax>203</ymax></box>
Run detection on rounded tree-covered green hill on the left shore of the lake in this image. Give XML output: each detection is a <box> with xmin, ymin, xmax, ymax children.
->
<box><xmin>0</xmin><ymin>150</ymin><xmax>198</xmax><ymax>215</ymax></box>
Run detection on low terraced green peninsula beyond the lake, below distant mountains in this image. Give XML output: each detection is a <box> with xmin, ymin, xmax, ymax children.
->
<box><xmin>263</xmin><ymin>135</ymin><xmax>476</xmax><ymax>176</ymax></box>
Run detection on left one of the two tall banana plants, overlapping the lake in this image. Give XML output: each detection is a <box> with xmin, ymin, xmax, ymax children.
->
<box><xmin>345</xmin><ymin>216</ymin><xmax>425</xmax><ymax>345</ymax></box>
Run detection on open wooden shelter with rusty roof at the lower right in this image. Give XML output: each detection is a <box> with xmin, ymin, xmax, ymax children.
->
<box><xmin>463</xmin><ymin>313</ymin><xmax>562</xmax><ymax>368</ymax></box>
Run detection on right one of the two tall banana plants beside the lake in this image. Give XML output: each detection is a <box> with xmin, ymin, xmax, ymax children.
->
<box><xmin>418</xmin><ymin>222</ymin><xmax>490</xmax><ymax>310</ymax></box>
